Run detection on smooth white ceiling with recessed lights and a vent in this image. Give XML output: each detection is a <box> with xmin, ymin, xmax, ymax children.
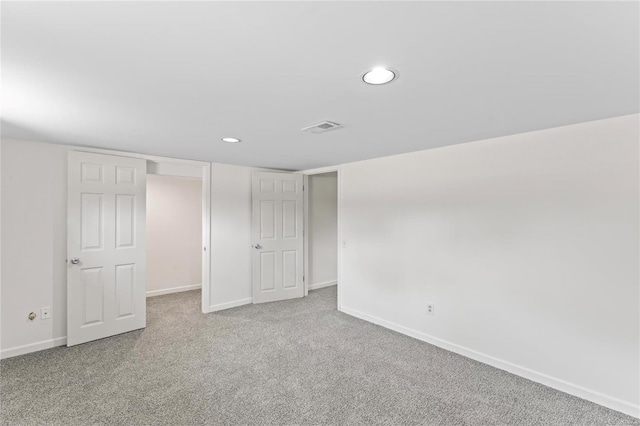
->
<box><xmin>1</xmin><ymin>1</ymin><xmax>640</xmax><ymax>169</ymax></box>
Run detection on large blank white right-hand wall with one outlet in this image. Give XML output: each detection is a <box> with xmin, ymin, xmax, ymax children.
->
<box><xmin>340</xmin><ymin>115</ymin><xmax>640</xmax><ymax>415</ymax></box>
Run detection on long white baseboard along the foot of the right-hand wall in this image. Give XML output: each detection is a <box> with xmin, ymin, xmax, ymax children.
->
<box><xmin>340</xmin><ymin>306</ymin><xmax>640</xmax><ymax>418</ymax></box>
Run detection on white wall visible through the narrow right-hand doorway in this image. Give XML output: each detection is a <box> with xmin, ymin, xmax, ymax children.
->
<box><xmin>307</xmin><ymin>172</ymin><xmax>338</xmax><ymax>290</ymax></box>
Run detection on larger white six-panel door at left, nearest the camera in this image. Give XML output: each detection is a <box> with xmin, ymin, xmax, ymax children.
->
<box><xmin>67</xmin><ymin>151</ymin><xmax>147</xmax><ymax>346</ymax></box>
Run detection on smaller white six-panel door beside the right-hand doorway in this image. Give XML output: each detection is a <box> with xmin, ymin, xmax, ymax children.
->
<box><xmin>251</xmin><ymin>172</ymin><xmax>304</xmax><ymax>303</ymax></box>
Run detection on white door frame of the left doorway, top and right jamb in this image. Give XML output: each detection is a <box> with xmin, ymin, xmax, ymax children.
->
<box><xmin>70</xmin><ymin>146</ymin><xmax>211</xmax><ymax>314</ymax></box>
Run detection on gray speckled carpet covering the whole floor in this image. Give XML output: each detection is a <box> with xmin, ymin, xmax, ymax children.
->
<box><xmin>0</xmin><ymin>287</ymin><xmax>640</xmax><ymax>426</ymax></box>
